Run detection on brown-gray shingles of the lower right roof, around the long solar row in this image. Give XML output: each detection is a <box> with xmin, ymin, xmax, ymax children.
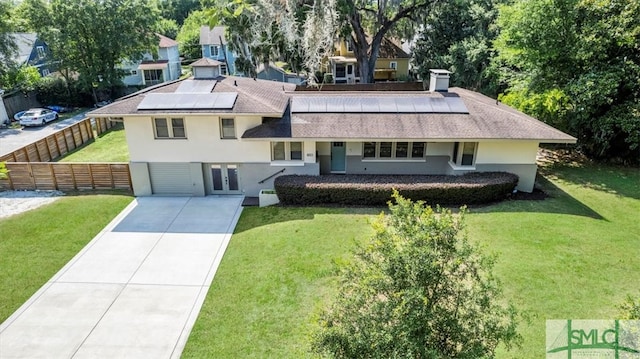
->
<box><xmin>242</xmin><ymin>88</ymin><xmax>576</xmax><ymax>143</ymax></box>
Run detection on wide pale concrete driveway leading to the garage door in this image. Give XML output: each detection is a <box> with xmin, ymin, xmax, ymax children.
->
<box><xmin>0</xmin><ymin>196</ymin><xmax>242</xmax><ymax>359</ymax></box>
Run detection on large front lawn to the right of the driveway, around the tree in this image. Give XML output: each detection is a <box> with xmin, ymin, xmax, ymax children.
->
<box><xmin>183</xmin><ymin>165</ymin><xmax>640</xmax><ymax>358</ymax></box>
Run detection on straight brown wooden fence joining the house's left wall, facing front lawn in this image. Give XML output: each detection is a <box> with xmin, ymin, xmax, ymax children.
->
<box><xmin>0</xmin><ymin>162</ymin><xmax>132</xmax><ymax>191</ymax></box>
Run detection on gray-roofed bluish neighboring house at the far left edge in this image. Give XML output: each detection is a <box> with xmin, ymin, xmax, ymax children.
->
<box><xmin>11</xmin><ymin>32</ymin><xmax>56</xmax><ymax>76</ymax></box>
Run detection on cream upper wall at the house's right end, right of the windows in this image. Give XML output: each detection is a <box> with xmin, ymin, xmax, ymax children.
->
<box><xmin>476</xmin><ymin>141</ymin><xmax>538</xmax><ymax>164</ymax></box>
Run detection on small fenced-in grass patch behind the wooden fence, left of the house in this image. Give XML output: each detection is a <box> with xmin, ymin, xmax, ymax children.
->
<box><xmin>57</xmin><ymin>127</ymin><xmax>129</xmax><ymax>162</ymax></box>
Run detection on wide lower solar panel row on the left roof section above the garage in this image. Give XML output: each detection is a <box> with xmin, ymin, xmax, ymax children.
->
<box><xmin>138</xmin><ymin>92</ymin><xmax>238</xmax><ymax>110</ymax></box>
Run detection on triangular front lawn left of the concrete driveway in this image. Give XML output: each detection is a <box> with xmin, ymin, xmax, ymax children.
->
<box><xmin>0</xmin><ymin>194</ymin><xmax>132</xmax><ymax>323</ymax></box>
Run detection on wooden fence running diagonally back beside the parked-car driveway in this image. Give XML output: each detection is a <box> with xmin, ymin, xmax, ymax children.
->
<box><xmin>0</xmin><ymin>118</ymin><xmax>114</xmax><ymax>162</ymax></box>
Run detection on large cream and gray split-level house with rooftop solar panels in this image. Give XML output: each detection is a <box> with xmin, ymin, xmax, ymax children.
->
<box><xmin>89</xmin><ymin>70</ymin><xmax>576</xmax><ymax>196</ymax></box>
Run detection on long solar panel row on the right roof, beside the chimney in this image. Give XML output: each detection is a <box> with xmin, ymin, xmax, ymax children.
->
<box><xmin>291</xmin><ymin>96</ymin><xmax>469</xmax><ymax>114</ymax></box>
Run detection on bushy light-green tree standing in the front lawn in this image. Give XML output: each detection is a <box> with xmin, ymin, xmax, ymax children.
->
<box><xmin>313</xmin><ymin>192</ymin><xmax>520</xmax><ymax>359</ymax></box>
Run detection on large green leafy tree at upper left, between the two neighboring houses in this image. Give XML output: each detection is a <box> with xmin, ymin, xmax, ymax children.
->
<box><xmin>25</xmin><ymin>0</ymin><xmax>158</xmax><ymax>100</ymax></box>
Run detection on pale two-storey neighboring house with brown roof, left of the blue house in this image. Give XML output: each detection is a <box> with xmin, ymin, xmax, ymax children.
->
<box><xmin>121</xmin><ymin>34</ymin><xmax>182</xmax><ymax>86</ymax></box>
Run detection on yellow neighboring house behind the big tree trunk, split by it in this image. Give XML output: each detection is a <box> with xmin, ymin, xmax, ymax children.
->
<box><xmin>328</xmin><ymin>38</ymin><xmax>410</xmax><ymax>83</ymax></box>
